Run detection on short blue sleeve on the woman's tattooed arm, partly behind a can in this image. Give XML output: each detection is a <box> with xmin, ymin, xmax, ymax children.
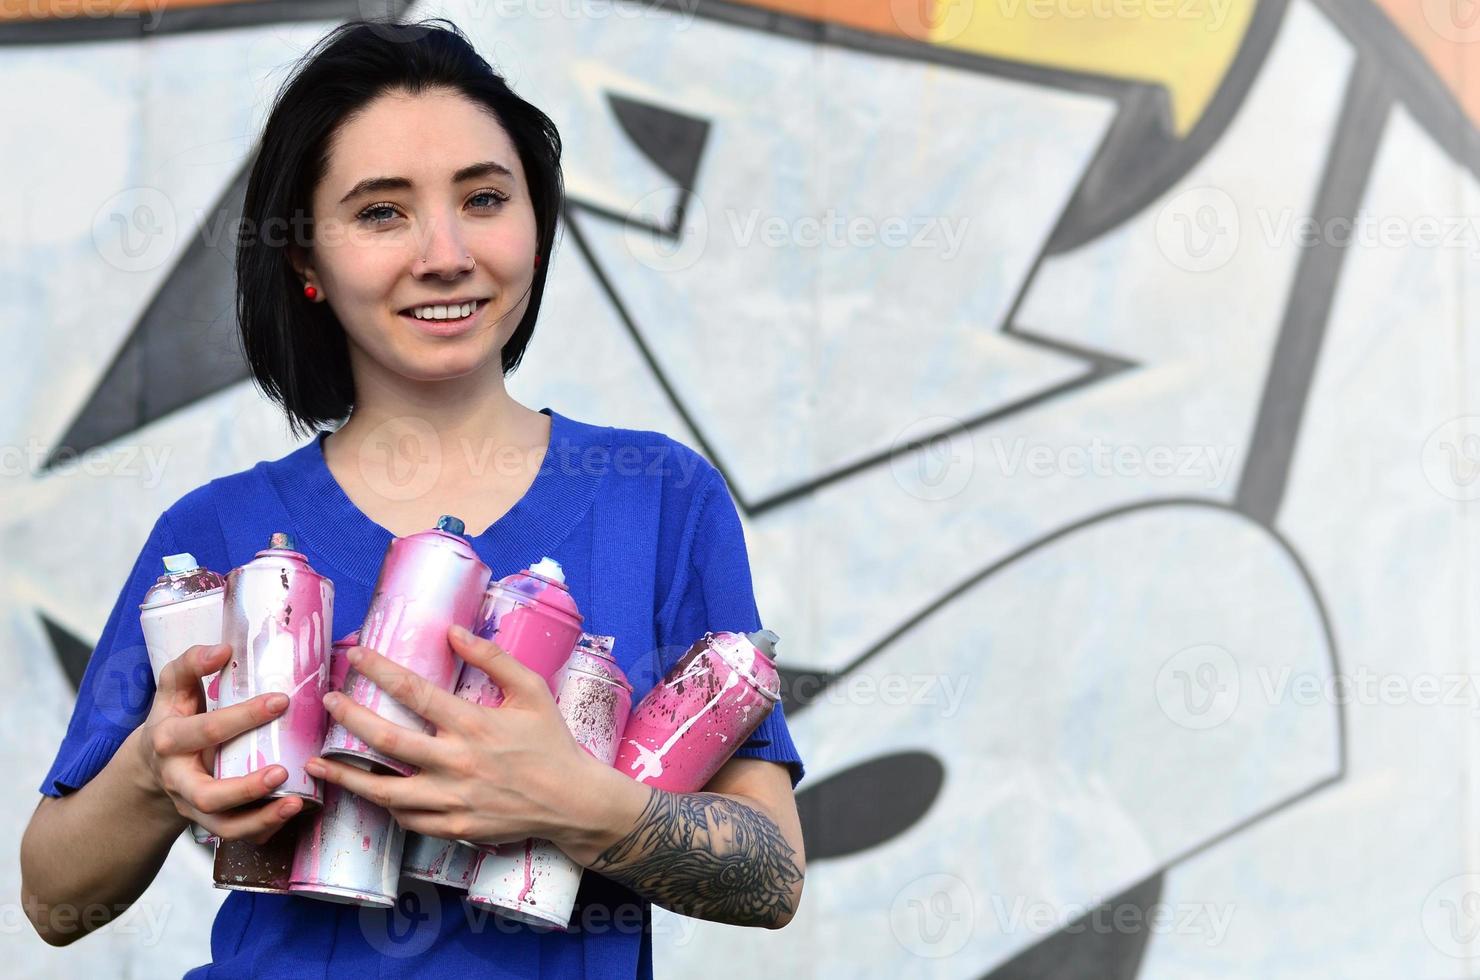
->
<box><xmin>659</xmin><ymin>468</ymin><xmax>805</xmax><ymax>789</ymax></box>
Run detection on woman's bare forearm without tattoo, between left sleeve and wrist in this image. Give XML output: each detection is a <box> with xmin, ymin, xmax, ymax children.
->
<box><xmin>21</xmin><ymin>728</ymin><xmax>188</xmax><ymax>946</ymax></box>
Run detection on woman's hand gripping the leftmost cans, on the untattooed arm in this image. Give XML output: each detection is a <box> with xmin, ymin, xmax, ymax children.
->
<box><xmin>133</xmin><ymin>644</ymin><xmax>303</xmax><ymax>844</ymax></box>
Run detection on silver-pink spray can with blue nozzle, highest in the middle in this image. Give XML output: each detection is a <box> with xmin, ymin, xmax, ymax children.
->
<box><xmin>323</xmin><ymin>515</ymin><xmax>491</xmax><ymax>776</ymax></box>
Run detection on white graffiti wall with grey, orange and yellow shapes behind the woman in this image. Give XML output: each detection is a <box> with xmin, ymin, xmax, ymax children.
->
<box><xmin>0</xmin><ymin>0</ymin><xmax>1480</xmax><ymax>980</ymax></box>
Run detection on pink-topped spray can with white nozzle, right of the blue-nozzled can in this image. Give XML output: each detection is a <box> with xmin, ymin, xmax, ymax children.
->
<box><xmin>406</xmin><ymin>558</ymin><xmax>582</xmax><ymax>887</ymax></box>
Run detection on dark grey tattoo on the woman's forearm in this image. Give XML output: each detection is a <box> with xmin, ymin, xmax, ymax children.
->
<box><xmin>591</xmin><ymin>789</ymin><xmax>802</xmax><ymax>925</ymax></box>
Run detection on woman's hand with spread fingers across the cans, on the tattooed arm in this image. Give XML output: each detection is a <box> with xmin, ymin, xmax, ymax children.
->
<box><xmin>308</xmin><ymin>626</ymin><xmax>604</xmax><ymax>844</ymax></box>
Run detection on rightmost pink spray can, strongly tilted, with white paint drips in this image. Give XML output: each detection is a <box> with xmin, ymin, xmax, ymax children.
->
<box><xmin>616</xmin><ymin>629</ymin><xmax>781</xmax><ymax>793</ymax></box>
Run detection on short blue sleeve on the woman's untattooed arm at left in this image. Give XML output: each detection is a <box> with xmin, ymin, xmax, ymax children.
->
<box><xmin>41</xmin><ymin>514</ymin><xmax>179</xmax><ymax>796</ymax></box>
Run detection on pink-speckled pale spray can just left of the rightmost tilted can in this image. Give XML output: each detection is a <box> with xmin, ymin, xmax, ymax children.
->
<box><xmin>468</xmin><ymin>634</ymin><xmax>632</xmax><ymax>930</ymax></box>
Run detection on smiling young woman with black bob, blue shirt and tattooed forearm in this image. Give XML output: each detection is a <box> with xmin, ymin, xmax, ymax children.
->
<box><xmin>22</xmin><ymin>21</ymin><xmax>804</xmax><ymax>979</ymax></box>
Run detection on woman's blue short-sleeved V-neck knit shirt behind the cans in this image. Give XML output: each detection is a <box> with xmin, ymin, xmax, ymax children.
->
<box><xmin>41</xmin><ymin>409</ymin><xmax>802</xmax><ymax>980</ymax></box>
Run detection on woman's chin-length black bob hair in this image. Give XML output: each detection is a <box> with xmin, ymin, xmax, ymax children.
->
<box><xmin>237</xmin><ymin>18</ymin><xmax>565</xmax><ymax>435</ymax></box>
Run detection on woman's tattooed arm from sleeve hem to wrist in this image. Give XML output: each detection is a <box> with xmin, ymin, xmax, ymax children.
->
<box><xmin>555</xmin><ymin>758</ymin><xmax>807</xmax><ymax>928</ymax></box>
